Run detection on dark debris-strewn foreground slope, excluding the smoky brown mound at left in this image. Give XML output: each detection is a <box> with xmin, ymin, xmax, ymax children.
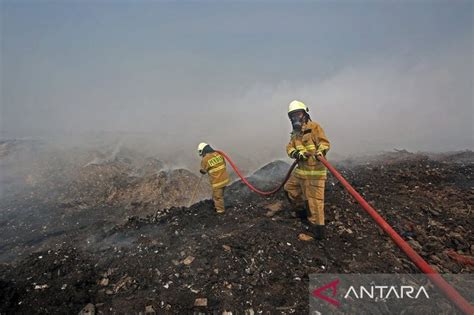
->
<box><xmin>0</xmin><ymin>153</ymin><xmax>474</xmax><ymax>314</ymax></box>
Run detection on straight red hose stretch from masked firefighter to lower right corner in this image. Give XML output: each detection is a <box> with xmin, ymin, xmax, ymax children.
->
<box><xmin>319</xmin><ymin>157</ymin><xmax>474</xmax><ymax>315</ymax></box>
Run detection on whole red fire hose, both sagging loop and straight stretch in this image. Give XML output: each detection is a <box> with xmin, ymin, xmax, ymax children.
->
<box><xmin>217</xmin><ymin>151</ymin><xmax>474</xmax><ymax>315</ymax></box>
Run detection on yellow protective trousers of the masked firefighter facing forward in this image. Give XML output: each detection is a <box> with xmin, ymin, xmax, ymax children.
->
<box><xmin>284</xmin><ymin>175</ymin><xmax>326</xmax><ymax>225</ymax></box>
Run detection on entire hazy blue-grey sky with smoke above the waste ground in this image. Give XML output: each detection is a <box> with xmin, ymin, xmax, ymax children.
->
<box><xmin>0</xmin><ymin>1</ymin><xmax>474</xmax><ymax>155</ymax></box>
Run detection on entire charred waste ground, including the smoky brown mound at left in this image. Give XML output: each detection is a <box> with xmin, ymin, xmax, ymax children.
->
<box><xmin>0</xmin><ymin>144</ymin><xmax>474</xmax><ymax>314</ymax></box>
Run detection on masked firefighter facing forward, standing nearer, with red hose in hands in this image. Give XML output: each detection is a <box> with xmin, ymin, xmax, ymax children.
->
<box><xmin>284</xmin><ymin>100</ymin><xmax>329</xmax><ymax>240</ymax></box>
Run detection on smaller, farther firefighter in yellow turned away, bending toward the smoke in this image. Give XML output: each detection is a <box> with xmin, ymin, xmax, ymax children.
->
<box><xmin>198</xmin><ymin>142</ymin><xmax>230</xmax><ymax>213</ymax></box>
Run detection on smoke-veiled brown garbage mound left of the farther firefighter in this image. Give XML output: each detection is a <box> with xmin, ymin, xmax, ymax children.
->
<box><xmin>2</xmin><ymin>141</ymin><xmax>210</xmax><ymax>214</ymax></box>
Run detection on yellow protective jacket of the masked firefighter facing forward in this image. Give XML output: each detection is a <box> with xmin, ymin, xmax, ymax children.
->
<box><xmin>286</xmin><ymin>121</ymin><xmax>330</xmax><ymax>179</ymax></box>
